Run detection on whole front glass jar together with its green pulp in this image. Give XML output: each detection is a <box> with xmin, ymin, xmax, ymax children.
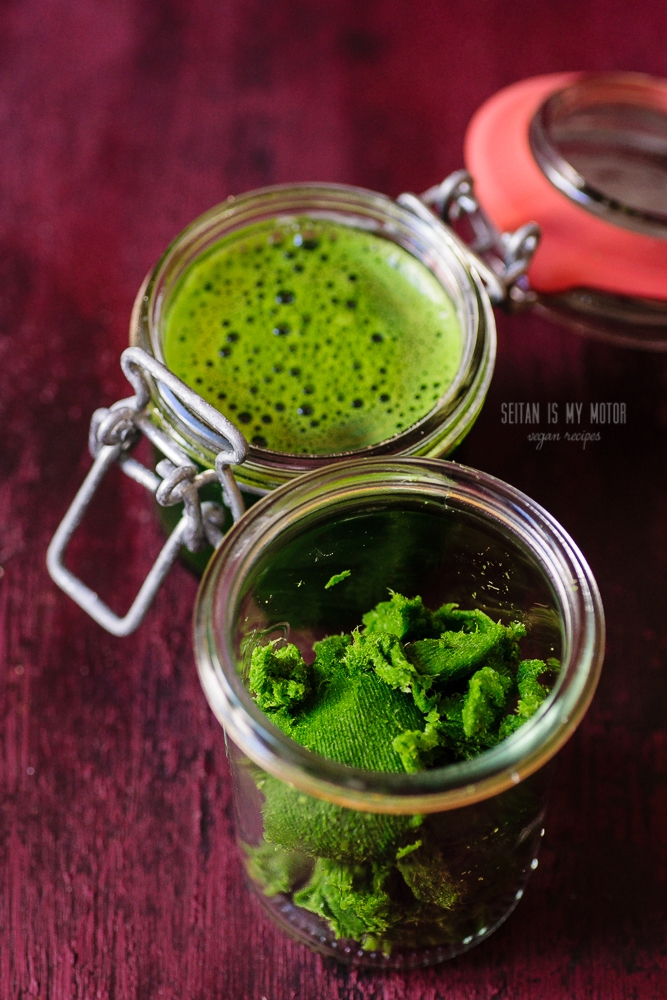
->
<box><xmin>195</xmin><ymin>457</ymin><xmax>604</xmax><ymax>968</ymax></box>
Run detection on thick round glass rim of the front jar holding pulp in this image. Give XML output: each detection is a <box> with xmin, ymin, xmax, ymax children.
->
<box><xmin>194</xmin><ymin>458</ymin><xmax>605</xmax><ymax>813</ymax></box>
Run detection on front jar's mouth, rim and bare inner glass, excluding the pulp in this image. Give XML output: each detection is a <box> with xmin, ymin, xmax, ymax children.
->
<box><xmin>195</xmin><ymin>459</ymin><xmax>603</xmax><ymax>813</ymax></box>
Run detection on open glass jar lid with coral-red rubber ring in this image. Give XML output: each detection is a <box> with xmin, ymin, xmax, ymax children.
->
<box><xmin>465</xmin><ymin>73</ymin><xmax>667</xmax><ymax>348</ymax></box>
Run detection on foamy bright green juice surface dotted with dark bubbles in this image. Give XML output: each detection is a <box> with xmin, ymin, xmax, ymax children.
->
<box><xmin>163</xmin><ymin>217</ymin><xmax>462</xmax><ymax>454</ymax></box>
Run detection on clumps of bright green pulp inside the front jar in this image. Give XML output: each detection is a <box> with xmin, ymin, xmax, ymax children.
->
<box><xmin>246</xmin><ymin>592</ymin><xmax>559</xmax><ymax>952</ymax></box>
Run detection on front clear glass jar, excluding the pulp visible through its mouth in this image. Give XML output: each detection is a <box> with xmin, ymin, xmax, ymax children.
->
<box><xmin>195</xmin><ymin>457</ymin><xmax>604</xmax><ymax>968</ymax></box>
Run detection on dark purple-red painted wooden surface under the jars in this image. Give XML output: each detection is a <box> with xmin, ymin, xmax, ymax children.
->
<box><xmin>0</xmin><ymin>0</ymin><xmax>667</xmax><ymax>1000</ymax></box>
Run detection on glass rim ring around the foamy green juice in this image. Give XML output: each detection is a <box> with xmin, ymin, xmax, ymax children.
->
<box><xmin>130</xmin><ymin>182</ymin><xmax>496</xmax><ymax>493</ymax></box>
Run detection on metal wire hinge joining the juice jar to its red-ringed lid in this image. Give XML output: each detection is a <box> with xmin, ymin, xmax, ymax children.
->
<box><xmin>398</xmin><ymin>170</ymin><xmax>540</xmax><ymax>309</ymax></box>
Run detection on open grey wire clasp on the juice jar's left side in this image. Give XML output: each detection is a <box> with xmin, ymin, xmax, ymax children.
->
<box><xmin>46</xmin><ymin>347</ymin><xmax>248</xmax><ymax>636</ymax></box>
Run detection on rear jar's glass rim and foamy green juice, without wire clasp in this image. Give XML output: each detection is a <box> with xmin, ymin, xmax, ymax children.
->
<box><xmin>130</xmin><ymin>185</ymin><xmax>495</xmax><ymax>494</ymax></box>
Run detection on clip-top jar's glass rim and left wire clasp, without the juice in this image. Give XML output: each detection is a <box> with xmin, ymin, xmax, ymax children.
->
<box><xmin>47</xmin><ymin>184</ymin><xmax>504</xmax><ymax>635</ymax></box>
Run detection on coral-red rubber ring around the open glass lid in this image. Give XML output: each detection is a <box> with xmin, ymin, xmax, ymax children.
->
<box><xmin>464</xmin><ymin>73</ymin><xmax>667</xmax><ymax>300</ymax></box>
